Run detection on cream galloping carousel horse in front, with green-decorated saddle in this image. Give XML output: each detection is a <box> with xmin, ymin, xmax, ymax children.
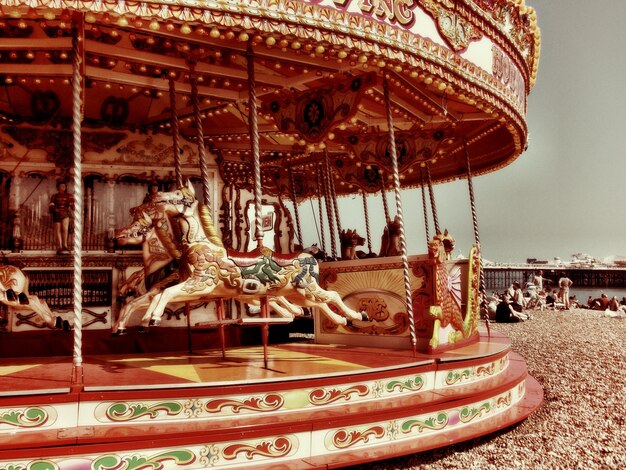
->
<box><xmin>141</xmin><ymin>182</ymin><xmax>367</xmax><ymax>325</ymax></box>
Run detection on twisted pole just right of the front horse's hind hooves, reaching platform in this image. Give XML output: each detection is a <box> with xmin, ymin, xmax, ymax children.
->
<box><xmin>383</xmin><ymin>77</ymin><xmax>417</xmax><ymax>355</ymax></box>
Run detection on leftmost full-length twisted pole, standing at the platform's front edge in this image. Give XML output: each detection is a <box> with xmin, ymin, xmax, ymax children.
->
<box><xmin>72</xmin><ymin>14</ymin><xmax>85</xmax><ymax>390</ymax></box>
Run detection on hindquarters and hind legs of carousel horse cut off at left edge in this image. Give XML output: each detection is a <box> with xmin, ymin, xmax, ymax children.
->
<box><xmin>0</xmin><ymin>265</ymin><xmax>70</xmax><ymax>331</ymax></box>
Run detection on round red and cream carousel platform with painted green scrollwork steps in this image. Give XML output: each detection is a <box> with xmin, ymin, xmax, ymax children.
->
<box><xmin>0</xmin><ymin>331</ymin><xmax>543</xmax><ymax>469</ymax></box>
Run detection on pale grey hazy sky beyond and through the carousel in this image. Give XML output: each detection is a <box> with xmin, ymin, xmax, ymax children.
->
<box><xmin>300</xmin><ymin>0</ymin><xmax>626</xmax><ymax>263</ymax></box>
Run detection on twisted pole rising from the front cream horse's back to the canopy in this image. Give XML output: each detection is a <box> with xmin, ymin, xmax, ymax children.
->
<box><xmin>246</xmin><ymin>42</ymin><xmax>263</xmax><ymax>248</ymax></box>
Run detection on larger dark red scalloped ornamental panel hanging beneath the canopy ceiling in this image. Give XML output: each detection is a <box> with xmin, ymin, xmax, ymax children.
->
<box><xmin>263</xmin><ymin>73</ymin><xmax>376</xmax><ymax>142</ymax></box>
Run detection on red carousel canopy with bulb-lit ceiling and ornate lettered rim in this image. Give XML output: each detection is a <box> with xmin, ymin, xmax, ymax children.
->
<box><xmin>0</xmin><ymin>0</ymin><xmax>540</xmax><ymax>197</ymax></box>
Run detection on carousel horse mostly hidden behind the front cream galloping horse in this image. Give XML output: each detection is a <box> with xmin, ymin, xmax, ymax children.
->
<box><xmin>112</xmin><ymin>203</ymin><xmax>304</xmax><ymax>336</ymax></box>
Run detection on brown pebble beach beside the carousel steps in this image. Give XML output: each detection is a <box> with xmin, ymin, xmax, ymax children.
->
<box><xmin>353</xmin><ymin>309</ymin><xmax>626</xmax><ymax>470</ymax></box>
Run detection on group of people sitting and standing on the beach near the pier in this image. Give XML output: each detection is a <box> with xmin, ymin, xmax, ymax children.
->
<box><xmin>486</xmin><ymin>271</ymin><xmax>626</xmax><ymax>323</ymax></box>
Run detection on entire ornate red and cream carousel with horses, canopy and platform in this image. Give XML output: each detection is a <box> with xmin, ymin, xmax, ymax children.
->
<box><xmin>0</xmin><ymin>0</ymin><xmax>543</xmax><ymax>469</ymax></box>
